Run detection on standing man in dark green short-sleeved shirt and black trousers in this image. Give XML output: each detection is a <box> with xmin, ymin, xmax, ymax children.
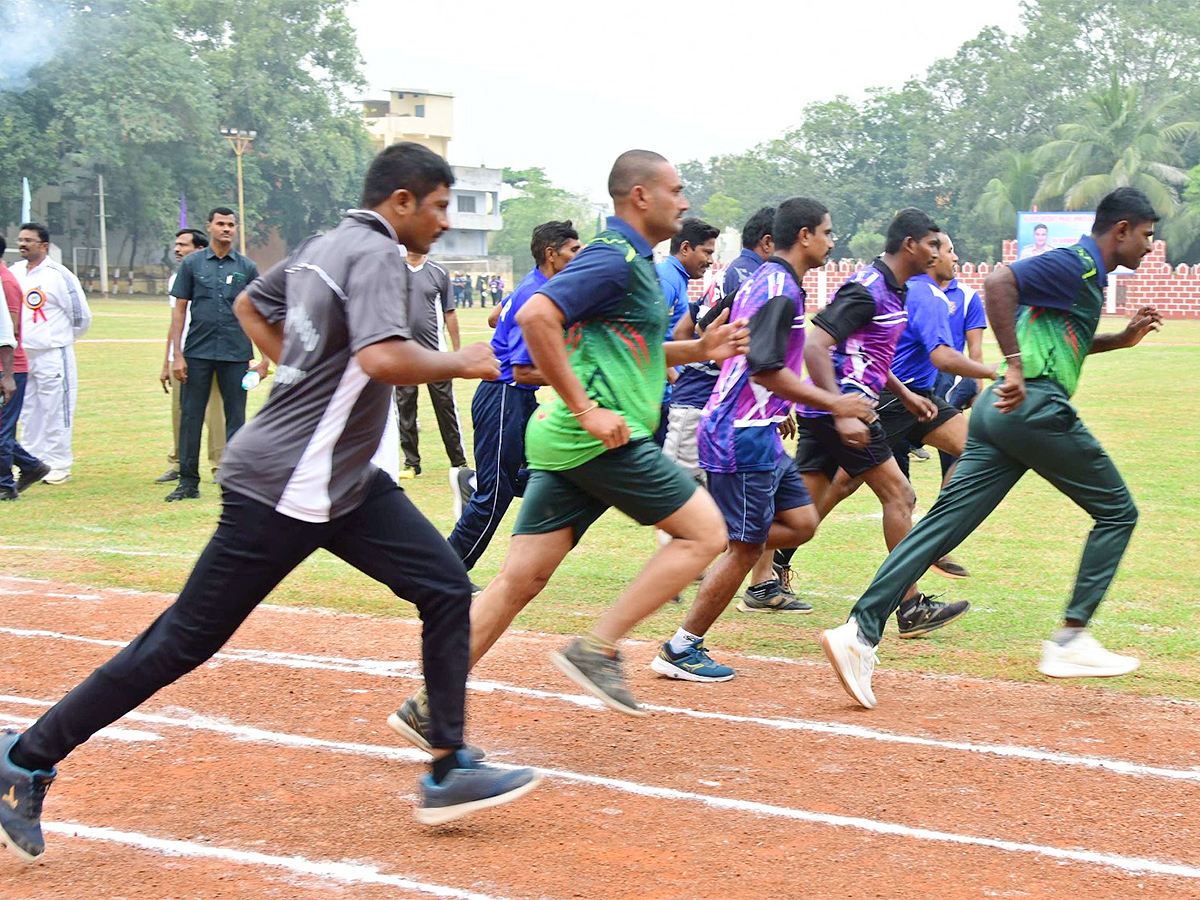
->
<box><xmin>167</xmin><ymin>206</ymin><xmax>266</xmax><ymax>503</ymax></box>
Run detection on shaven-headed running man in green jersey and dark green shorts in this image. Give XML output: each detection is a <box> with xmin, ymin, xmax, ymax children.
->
<box><xmin>392</xmin><ymin>150</ymin><xmax>746</xmax><ymax>746</ymax></box>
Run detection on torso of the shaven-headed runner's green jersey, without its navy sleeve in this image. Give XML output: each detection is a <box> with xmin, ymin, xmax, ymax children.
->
<box><xmin>526</xmin><ymin>229</ymin><xmax>667</xmax><ymax>470</ymax></box>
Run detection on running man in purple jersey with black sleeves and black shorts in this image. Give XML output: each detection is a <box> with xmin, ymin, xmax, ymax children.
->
<box><xmin>796</xmin><ymin>208</ymin><xmax>970</xmax><ymax>637</ymax></box>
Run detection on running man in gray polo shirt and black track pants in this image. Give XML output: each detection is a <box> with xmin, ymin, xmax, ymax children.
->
<box><xmin>0</xmin><ymin>143</ymin><xmax>538</xmax><ymax>860</ymax></box>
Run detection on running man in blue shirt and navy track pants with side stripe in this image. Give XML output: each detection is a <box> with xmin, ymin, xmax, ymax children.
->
<box><xmin>448</xmin><ymin>222</ymin><xmax>583</xmax><ymax>571</ymax></box>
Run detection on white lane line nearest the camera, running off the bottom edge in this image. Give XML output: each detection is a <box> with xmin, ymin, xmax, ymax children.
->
<box><xmin>42</xmin><ymin>822</ymin><xmax>513</xmax><ymax>900</ymax></box>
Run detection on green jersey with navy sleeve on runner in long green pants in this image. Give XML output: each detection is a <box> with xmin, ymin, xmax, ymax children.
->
<box><xmin>1013</xmin><ymin>236</ymin><xmax>1108</xmax><ymax>396</ymax></box>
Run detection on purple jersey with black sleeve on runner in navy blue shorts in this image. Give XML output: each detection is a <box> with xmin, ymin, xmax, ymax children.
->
<box><xmin>696</xmin><ymin>257</ymin><xmax>804</xmax><ymax>472</ymax></box>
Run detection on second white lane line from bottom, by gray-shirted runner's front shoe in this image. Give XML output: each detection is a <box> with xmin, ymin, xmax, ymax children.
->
<box><xmin>0</xmin><ymin>697</ymin><xmax>1200</xmax><ymax>878</ymax></box>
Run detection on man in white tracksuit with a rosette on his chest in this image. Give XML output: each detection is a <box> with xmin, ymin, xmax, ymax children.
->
<box><xmin>12</xmin><ymin>222</ymin><xmax>91</xmax><ymax>485</ymax></box>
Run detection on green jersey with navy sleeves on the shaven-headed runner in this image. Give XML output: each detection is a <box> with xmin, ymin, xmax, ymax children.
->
<box><xmin>526</xmin><ymin>220</ymin><xmax>667</xmax><ymax>470</ymax></box>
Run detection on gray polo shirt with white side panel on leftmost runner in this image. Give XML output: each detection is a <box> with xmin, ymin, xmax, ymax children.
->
<box><xmin>219</xmin><ymin>210</ymin><xmax>412</xmax><ymax>522</ymax></box>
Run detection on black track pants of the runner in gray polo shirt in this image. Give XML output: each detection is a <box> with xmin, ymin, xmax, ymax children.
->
<box><xmin>18</xmin><ymin>472</ymin><xmax>470</xmax><ymax>769</ymax></box>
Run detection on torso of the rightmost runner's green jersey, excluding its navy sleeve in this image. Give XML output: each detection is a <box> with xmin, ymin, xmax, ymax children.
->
<box><xmin>1016</xmin><ymin>244</ymin><xmax>1104</xmax><ymax>397</ymax></box>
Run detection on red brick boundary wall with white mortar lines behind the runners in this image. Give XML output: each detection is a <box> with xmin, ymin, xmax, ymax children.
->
<box><xmin>689</xmin><ymin>241</ymin><xmax>1200</xmax><ymax>319</ymax></box>
